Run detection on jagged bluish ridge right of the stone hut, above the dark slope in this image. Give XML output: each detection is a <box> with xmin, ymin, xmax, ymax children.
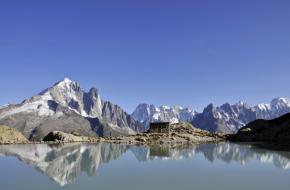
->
<box><xmin>191</xmin><ymin>98</ymin><xmax>290</xmax><ymax>133</ymax></box>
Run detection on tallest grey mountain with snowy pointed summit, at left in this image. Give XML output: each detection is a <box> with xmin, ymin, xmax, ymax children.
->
<box><xmin>0</xmin><ymin>78</ymin><xmax>142</xmax><ymax>139</ymax></box>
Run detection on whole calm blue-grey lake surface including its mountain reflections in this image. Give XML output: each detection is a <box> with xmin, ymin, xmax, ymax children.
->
<box><xmin>0</xmin><ymin>142</ymin><xmax>290</xmax><ymax>190</ymax></box>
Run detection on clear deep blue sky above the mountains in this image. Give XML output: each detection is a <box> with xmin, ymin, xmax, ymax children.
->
<box><xmin>0</xmin><ymin>0</ymin><xmax>290</xmax><ymax>112</ymax></box>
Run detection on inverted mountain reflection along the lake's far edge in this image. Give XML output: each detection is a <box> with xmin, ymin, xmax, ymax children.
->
<box><xmin>0</xmin><ymin>142</ymin><xmax>290</xmax><ymax>186</ymax></box>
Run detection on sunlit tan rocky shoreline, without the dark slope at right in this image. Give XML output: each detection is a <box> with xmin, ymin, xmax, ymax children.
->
<box><xmin>0</xmin><ymin>123</ymin><xmax>226</xmax><ymax>145</ymax></box>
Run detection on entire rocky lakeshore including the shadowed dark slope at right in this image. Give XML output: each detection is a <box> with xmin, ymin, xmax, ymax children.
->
<box><xmin>0</xmin><ymin>114</ymin><xmax>290</xmax><ymax>150</ymax></box>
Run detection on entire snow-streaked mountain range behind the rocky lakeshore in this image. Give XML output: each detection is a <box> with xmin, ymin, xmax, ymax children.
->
<box><xmin>0</xmin><ymin>78</ymin><xmax>290</xmax><ymax>140</ymax></box>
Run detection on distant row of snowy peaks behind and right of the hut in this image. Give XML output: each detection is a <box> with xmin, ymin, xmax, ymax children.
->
<box><xmin>132</xmin><ymin>98</ymin><xmax>290</xmax><ymax>133</ymax></box>
